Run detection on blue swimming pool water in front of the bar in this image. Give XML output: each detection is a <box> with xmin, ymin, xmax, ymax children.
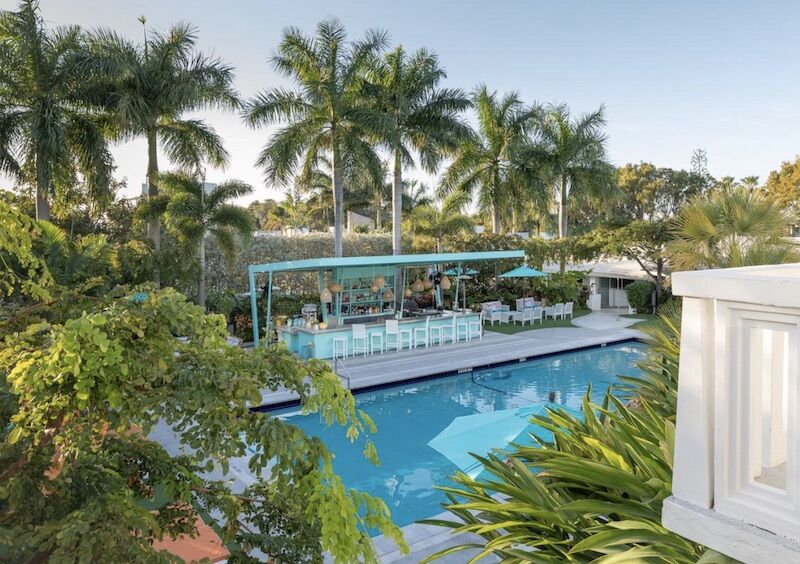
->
<box><xmin>275</xmin><ymin>342</ymin><xmax>644</xmax><ymax>526</ymax></box>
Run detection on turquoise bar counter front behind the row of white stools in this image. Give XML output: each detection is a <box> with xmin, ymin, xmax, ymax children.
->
<box><xmin>276</xmin><ymin>311</ymin><xmax>480</xmax><ymax>359</ymax></box>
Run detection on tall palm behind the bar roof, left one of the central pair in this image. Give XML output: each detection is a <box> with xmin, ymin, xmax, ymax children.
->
<box><xmin>244</xmin><ymin>19</ymin><xmax>386</xmax><ymax>256</ymax></box>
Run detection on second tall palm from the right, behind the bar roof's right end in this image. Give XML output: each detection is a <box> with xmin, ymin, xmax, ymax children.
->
<box><xmin>440</xmin><ymin>86</ymin><xmax>537</xmax><ymax>234</ymax></box>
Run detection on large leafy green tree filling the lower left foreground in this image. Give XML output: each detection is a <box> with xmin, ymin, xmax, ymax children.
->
<box><xmin>0</xmin><ymin>202</ymin><xmax>405</xmax><ymax>563</ymax></box>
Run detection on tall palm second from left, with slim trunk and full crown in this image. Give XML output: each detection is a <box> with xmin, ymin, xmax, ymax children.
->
<box><xmin>85</xmin><ymin>17</ymin><xmax>240</xmax><ymax>256</ymax></box>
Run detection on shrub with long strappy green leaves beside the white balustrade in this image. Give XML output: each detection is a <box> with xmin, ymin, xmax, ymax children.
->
<box><xmin>426</xmin><ymin>300</ymin><xmax>730</xmax><ymax>563</ymax></box>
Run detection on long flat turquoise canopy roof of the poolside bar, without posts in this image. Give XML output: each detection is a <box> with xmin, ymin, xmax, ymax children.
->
<box><xmin>248</xmin><ymin>249</ymin><xmax>525</xmax><ymax>274</ymax></box>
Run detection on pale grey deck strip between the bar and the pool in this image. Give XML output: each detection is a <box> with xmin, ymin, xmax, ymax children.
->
<box><xmin>262</xmin><ymin>312</ymin><xmax>641</xmax><ymax>406</ymax></box>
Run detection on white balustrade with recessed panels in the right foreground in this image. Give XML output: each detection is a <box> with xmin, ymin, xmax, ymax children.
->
<box><xmin>663</xmin><ymin>264</ymin><xmax>800</xmax><ymax>564</ymax></box>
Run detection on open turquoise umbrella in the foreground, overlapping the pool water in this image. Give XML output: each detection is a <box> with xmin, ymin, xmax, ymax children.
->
<box><xmin>428</xmin><ymin>402</ymin><xmax>580</xmax><ymax>478</ymax></box>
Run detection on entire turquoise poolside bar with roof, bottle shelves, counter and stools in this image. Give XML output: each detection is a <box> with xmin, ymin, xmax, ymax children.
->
<box><xmin>248</xmin><ymin>250</ymin><xmax>525</xmax><ymax>359</ymax></box>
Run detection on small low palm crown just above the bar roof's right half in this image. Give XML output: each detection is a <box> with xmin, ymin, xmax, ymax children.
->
<box><xmin>407</xmin><ymin>192</ymin><xmax>473</xmax><ymax>253</ymax></box>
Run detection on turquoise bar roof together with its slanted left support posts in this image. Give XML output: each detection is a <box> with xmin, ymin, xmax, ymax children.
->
<box><xmin>248</xmin><ymin>250</ymin><xmax>525</xmax><ymax>349</ymax></box>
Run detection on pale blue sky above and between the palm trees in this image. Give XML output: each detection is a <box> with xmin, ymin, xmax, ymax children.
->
<box><xmin>0</xmin><ymin>0</ymin><xmax>800</xmax><ymax>203</ymax></box>
